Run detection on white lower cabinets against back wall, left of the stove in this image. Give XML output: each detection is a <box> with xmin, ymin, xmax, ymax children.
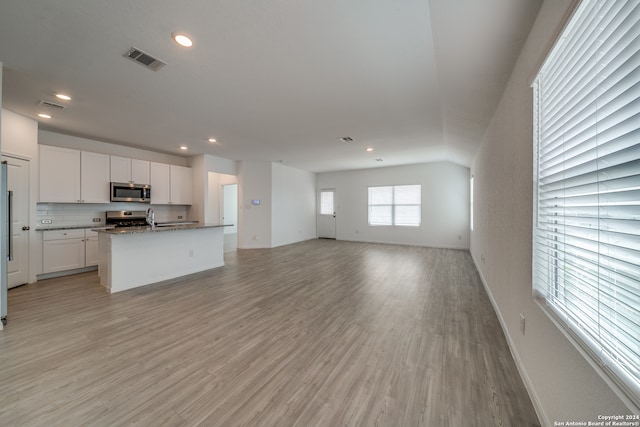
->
<box><xmin>42</xmin><ymin>229</ymin><xmax>98</xmax><ymax>274</ymax></box>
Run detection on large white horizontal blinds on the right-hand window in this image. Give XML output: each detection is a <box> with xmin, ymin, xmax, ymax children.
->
<box><xmin>533</xmin><ymin>0</ymin><xmax>640</xmax><ymax>408</ymax></box>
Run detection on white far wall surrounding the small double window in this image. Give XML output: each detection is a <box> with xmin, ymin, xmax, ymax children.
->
<box><xmin>317</xmin><ymin>162</ymin><xmax>469</xmax><ymax>249</ymax></box>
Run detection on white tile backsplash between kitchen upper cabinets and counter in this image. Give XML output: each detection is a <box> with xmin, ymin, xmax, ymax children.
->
<box><xmin>36</xmin><ymin>203</ymin><xmax>188</xmax><ymax>228</ymax></box>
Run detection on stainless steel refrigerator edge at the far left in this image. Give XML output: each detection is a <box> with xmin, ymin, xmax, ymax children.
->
<box><xmin>0</xmin><ymin>162</ymin><xmax>12</xmax><ymax>325</ymax></box>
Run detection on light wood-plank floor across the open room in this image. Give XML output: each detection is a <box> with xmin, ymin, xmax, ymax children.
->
<box><xmin>0</xmin><ymin>240</ymin><xmax>538</xmax><ymax>427</ymax></box>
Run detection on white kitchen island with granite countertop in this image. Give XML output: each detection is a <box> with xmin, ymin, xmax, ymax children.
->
<box><xmin>94</xmin><ymin>224</ymin><xmax>224</xmax><ymax>293</ymax></box>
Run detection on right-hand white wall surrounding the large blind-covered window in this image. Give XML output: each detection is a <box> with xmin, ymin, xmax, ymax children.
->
<box><xmin>471</xmin><ymin>0</ymin><xmax>630</xmax><ymax>425</ymax></box>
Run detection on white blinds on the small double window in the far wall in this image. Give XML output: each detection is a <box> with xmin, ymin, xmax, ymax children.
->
<box><xmin>369</xmin><ymin>185</ymin><xmax>422</xmax><ymax>226</ymax></box>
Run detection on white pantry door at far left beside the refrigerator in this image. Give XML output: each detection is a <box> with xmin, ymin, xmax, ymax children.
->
<box><xmin>2</xmin><ymin>156</ymin><xmax>29</xmax><ymax>288</ymax></box>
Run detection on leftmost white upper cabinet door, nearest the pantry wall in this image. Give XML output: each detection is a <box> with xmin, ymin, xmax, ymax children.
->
<box><xmin>39</xmin><ymin>145</ymin><xmax>80</xmax><ymax>203</ymax></box>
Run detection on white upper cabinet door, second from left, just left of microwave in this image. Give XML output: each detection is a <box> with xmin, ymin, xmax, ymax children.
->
<box><xmin>80</xmin><ymin>151</ymin><xmax>111</xmax><ymax>203</ymax></box>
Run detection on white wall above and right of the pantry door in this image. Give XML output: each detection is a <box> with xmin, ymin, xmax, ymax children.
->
<box><xmin>0</xmin><ymin>109</ymin><xmax>42</xmax><ymax>282</ymax></box>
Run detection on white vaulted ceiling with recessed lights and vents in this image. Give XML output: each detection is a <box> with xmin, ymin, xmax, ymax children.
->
<box><xmin>0</xmin><ymin>0</ymin><xmax>541</xmax><ymax>172</ymax></box>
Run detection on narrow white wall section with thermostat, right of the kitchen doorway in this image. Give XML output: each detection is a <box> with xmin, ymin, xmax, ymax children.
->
<box><xmin>238</xmin><ymin>161</ymin><xmax>272</xmax><ymax>249</ymax></box>
